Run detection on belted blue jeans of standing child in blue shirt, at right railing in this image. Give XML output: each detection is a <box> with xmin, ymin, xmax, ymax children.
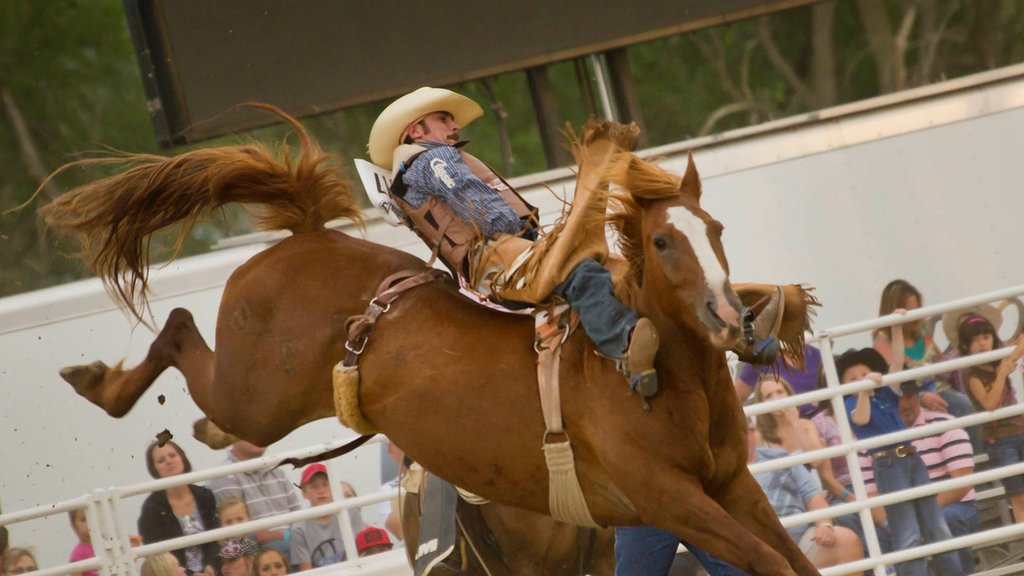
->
<box><xmin>871</xmin><ymin>454</ymin><xmax>964</xmax><ymax>576</ymax></box>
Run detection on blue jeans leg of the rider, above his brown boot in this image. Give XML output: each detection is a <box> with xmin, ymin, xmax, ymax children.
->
<box><xmin>552</xmin><ymin>258</ymin><xmax>640</xmax><ymax>359</ymax></box>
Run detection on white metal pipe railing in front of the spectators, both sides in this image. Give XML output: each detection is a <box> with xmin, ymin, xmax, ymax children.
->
<box><xmin>6</xmin><ymin>286</ymin><xmax>1024</xmax><ymax>576</ymax></box>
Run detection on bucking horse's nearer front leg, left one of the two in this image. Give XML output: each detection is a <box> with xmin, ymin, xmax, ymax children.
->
<box><xmin>621</xmin><ymin>463</ymin><xmax>817</xmax><ymax>576</ymax></box>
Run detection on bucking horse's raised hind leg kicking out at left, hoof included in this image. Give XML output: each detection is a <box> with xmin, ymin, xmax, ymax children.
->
<box><xmin>60</xmin><ymin>308</ymin><xmax>213</xmax><ymax>418</ymax></box>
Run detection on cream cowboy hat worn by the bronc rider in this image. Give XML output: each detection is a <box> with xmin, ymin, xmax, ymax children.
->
<box><xmin>367</xmin><ymin>86</ymin><xmax>483</xmax><ymax>169</ymax></box>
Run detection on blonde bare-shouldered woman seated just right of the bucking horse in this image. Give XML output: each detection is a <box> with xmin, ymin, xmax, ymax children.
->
<box><xmin>754</xmin><ymin>376</ymin><xmax>846</xmax><ymax>495</ymax></box>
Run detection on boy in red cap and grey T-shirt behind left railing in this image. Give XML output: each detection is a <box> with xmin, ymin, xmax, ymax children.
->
<box><xmin>291</xmin><ymin>463</ymin><xmax>345</xmax><ymax>570</ymax></box>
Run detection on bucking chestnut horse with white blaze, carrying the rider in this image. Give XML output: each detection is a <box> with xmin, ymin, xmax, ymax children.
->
<box><xmin>42</xmin><ymin>113</ymin><xmax>817</xmax><ymax>575</ymax></box>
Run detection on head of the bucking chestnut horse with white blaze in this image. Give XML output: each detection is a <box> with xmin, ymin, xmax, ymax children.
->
<box><xmin>611</xmin><ymin>156</ymin><xmax>742</xmax><ymax>349</ymax></box>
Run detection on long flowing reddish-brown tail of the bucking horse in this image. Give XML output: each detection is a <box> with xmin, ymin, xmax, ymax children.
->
<box><xmin>40</xmin><ymin>104</ymin><xmax>361</xmax><ymax>318</ymax></box>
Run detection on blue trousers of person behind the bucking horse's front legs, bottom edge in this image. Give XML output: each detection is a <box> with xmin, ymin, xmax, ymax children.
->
<box><xmin>615</xmin><ymin>526</ymin><xmax>746</xmax><ymax>576</ymax></box>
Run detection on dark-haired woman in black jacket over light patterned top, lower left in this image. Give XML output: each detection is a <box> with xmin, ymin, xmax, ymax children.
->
<box><xmin>138</xmin><ymin>441</ymin><xmax>220</xmax><ymax>576</ymax></box>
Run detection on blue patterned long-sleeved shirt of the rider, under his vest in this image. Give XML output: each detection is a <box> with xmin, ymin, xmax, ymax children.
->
<box><xmin>401</xmin><ymin>141</ymin><xmax>523</xmax><ymax>238</ymax></box>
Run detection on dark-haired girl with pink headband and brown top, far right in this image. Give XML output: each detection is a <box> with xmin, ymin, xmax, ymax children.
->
<box><xmin>957</xmin><ymin>315</ymin><xmax>1024</xmax><ymax>523</ymax></box>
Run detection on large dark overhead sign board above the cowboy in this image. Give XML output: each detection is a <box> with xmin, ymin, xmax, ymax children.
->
<box><xmin>125</xmin><ymin>0</ymin><xmax>816</xmax><ymax>146</ymax></box>
